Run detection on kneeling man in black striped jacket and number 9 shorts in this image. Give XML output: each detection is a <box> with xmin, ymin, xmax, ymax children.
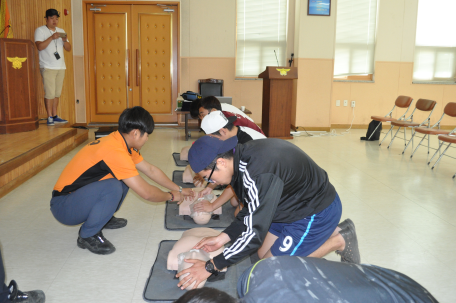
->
<box><xmin>179</xmin><ymin>136</ymin><xmax>360</xmax><ymax>287</ymax></box>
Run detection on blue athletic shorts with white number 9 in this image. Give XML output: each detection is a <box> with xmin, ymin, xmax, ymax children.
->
<box><xmin>269</xmin><ymin>193</ymin><xmax>342</xmax><ymax>257</ymax></box>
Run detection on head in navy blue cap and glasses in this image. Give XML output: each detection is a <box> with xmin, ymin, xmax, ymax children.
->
<box><xmin>188</xmin><ymin>136</ymin><xmax>237</xmax><ymax>185</ymax></box>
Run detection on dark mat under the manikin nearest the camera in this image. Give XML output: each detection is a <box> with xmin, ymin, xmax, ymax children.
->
<box><xmin>143</xmin><ymin>240</ymin><xmax>252</xmax><ymax>302</ymax></box>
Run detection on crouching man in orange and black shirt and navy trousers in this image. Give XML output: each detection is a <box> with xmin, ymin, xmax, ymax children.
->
<box><xmin>51</xmin><ymin>106</ymin><xmax>194</xmax><ymax>254</ymax></box>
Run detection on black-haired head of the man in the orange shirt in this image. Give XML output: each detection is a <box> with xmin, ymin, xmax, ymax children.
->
<box><xmin>119</xmin><ymin>106</ymin><xmax>155</xmax><ymax>150</ymax></box>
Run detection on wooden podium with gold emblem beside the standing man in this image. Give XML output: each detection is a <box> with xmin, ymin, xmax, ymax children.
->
<box><xmin>0</xmin><ymin>39</ymin><xmax>39</xmax><ymax>134</ymax></box>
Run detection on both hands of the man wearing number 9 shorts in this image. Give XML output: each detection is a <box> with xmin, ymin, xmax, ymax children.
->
<box><xmin>176</xmin><ymin>233</ymin><xmax>230</xmax><ymax>289</ymax></box>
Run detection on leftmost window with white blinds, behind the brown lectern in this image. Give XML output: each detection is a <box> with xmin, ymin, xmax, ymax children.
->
<box><xmin>236</xmin><ymin>0</ymin><xmax>288</xmax><ymax>77</ymax></box>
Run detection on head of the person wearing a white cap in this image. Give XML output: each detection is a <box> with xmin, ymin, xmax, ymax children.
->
<box><xmin>201</xmin><ymin>110</ymin><xmax>237</xmax><ymax>141</ymax></box>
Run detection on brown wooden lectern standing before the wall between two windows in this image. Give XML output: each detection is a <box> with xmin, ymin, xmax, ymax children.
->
<box><xmin>258</xmin><ymin>66</ymin><xmax>298</xmax><ymax>139</ymax></box>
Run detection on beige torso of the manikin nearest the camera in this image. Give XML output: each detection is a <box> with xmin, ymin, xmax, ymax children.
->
<box><xmin>167</xmin><ymin>227</ymin><xmax>224</xmax><ymax>272</ymax></box>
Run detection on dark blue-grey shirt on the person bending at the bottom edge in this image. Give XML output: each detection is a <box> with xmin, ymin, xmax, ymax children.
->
<box><xmin>238</xmin><ymin>256</ymin><xmax>438</xmax><ymax>303</ymax></box>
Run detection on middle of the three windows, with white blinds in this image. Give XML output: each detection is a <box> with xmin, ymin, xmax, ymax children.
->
<box><xmin>334</xmin><ymin>0</ymin><xmax>377</xmax><ymax>76</ymax></box>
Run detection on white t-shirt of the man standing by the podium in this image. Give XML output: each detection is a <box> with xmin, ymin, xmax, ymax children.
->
<box><xmin>35</xmin><ymin>25</ymin><xmax>66</xmax><ymax>69</ymax></box>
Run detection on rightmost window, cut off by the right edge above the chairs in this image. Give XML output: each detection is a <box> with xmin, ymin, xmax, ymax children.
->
<box><xmin>413</xmin><ymin>0</ymin><xmax>456</xmax><ymax>82</ymax></box>
